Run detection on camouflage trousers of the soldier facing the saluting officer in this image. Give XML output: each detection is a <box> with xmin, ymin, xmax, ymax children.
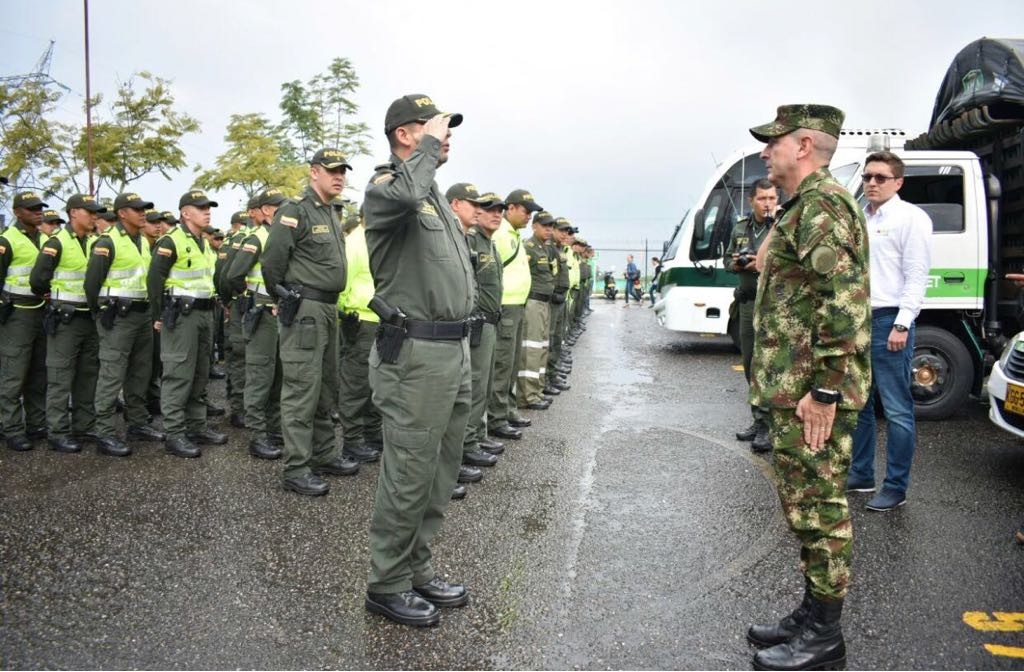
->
<box><xmin>769</xmin><ymin>409</ymin><xmax>858</xmax><ymax>599</ymax></box>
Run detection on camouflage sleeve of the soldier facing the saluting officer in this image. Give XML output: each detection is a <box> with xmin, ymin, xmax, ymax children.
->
<box><xmin>797</xmin><ymin>196</ymin><xmax>870</xmax><ymax>390</ymax></box>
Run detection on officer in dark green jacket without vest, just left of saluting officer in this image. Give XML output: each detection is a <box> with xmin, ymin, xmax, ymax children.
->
<box><xmin>260</xmin><ymin>149</ymin><xmax>359</xmax><ymax>496</ymax></box>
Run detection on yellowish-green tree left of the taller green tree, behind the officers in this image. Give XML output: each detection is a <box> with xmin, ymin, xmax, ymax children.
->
<box><xmin>196</xmin><ymin>114</ymin><xmax>309</xmax><ymax>197</ymax></box>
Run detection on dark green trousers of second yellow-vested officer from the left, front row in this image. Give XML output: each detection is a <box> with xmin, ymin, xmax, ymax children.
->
<box><xmin>46</xmin><ymin>310</ymin><xmax>99</xmax><ymax>438</ymax></box>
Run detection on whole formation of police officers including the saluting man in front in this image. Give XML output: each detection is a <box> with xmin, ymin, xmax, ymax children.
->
<box><xmin>0</xmin><ymin>89</ymin><xmax>593</xmax><ymax>625</ymax></box>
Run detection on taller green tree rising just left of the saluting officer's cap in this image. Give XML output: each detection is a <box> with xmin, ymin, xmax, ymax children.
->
<box><xmin>280</xmin><ymin>57</ymin><xmax>370</xmax><ymax>161</ymax></box>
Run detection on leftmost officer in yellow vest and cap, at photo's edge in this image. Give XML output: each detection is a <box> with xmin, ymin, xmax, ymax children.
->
<box><xmin>0</xmin><ymin>192</ymin><xmax>47</xmax><ymax>451</ymax></box>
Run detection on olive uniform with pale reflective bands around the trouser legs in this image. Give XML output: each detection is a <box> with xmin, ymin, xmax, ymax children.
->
<box><xmin>516</xmin><ymin>225</ymin><xmax>558</xmax><ymax>408</ymax></box>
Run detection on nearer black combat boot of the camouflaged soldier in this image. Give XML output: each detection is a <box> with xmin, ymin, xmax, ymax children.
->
<box><xmin>754</xmin><ymin>596</ymin><xmax>846</xmax><ymax>670</ymax></box>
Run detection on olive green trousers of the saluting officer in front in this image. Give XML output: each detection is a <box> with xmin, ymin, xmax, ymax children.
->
<box><xmin>369</xmin><ymin>338</ymin><xmax>472</xmax><ymax>593</ymax></box>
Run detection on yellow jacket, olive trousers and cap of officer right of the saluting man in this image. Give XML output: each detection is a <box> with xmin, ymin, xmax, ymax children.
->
<box><xmin>487</xmin><ymin>199</ymin><xmax>539</xmax><ymax>430</ymax></box>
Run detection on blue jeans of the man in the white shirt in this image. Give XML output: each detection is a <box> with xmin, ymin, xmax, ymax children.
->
<box><xmin>850</xmin><ymin>310</ymin><xmax>916</xmax><ymax>494</ymax></box>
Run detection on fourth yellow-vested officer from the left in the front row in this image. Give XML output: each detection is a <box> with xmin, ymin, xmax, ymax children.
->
<box><xmin>146</xmin><ymin>190</ymin><xmax>227</xmax><ymax>458</ymax></box>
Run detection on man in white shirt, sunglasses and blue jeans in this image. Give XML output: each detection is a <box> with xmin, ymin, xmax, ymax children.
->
<box><xmin>847</xmin><ymin>152</ymin><xmax>932</xmax><ymax>511</ymax></box>
